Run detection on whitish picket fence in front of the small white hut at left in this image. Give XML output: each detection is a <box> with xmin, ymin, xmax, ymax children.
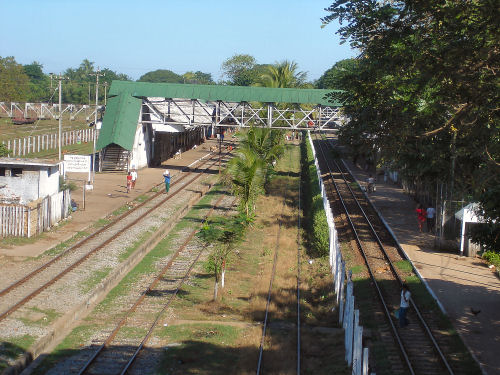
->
<box><xmin>0</xmin><ymin>190</ymin><xmax>71</xmax><ymax>237</ymax></box>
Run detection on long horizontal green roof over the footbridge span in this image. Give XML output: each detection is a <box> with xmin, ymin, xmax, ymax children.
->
<box><xmin>109</xmin><ymin>81</ymin><xmax>341</xmax><ymax>107</ymax></box>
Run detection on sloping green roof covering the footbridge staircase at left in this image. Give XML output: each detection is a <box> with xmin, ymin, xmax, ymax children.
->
<box><xmin>96</xmin><ymin>92</ymin><xmax>142</xmax><ymax>151</ymax></box>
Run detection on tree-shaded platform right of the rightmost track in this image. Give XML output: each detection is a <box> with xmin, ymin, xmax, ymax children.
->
<box><xmin>346</xmin><ymin>160</ymin><xmax>500</xmax><ymax>375</ymax></box>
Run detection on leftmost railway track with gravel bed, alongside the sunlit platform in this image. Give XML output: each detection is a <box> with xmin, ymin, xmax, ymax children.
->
<box><xmin>0</xmin><ymin>148</ymin><xmax>233</xmax><ymax>323</ymax></box>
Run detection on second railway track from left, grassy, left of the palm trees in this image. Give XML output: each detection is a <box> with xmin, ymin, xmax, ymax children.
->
<box><xmin>70</xmin><ymin>195</ymin><xmax>236</xmax><ymax>375</ymax></box>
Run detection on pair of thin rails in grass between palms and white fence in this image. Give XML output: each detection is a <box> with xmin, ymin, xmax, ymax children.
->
<box><xmin>257</xmin><ymin>148</ymin><xmax>301</xmax><ymax>375</ymax></box>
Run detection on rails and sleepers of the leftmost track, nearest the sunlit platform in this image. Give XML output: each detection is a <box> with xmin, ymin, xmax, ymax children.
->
<box><xmin>0</xmin><ymin>153</ymin><xmax>229</xmax><ymax>322</ymax></box>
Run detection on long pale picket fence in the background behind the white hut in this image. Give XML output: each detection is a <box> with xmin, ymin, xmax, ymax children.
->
<box><xmin>2</xmin><ymin>128</ymin><xmax>99</xmax><ymax>157</ymax></box>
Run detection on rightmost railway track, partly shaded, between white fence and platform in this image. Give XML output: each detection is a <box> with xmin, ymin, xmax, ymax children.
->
<box><xmin>314</xmin><ymin>137</ymin><xmax>459</xmax><ymax>375</ymax></box>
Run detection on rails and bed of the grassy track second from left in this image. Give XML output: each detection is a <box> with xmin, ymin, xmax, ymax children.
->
<box><xmin>78</xmin><ymin>195</ymin><xmax>236</xmax><ymax>375</ymax></box>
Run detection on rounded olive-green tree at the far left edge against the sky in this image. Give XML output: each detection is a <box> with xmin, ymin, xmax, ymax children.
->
<box><xmin>0</xmin><ymin>56</ymin><xmax>29</xmax><ymax>102</ymax></box>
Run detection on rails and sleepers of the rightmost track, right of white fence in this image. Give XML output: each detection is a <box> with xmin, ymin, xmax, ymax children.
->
<box><xmin>315</xmin><ymin>136</ymin><xmax>453</xmax><ymax>374</ymax></box>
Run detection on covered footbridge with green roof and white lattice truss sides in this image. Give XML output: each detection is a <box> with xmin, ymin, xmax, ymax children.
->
<box><xmin>97</xmin><ymin>81</ymin><xmax>344</xmax><ymax>150</ymax></box>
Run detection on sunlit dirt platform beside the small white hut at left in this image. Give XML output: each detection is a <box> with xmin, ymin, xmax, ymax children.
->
<box><xmin>0</xmin><ymin>139</ymin><xmax>225</xmax><ymax>259</ymax></box>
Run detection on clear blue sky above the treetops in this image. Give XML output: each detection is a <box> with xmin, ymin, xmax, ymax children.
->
<box><xmin>0</xmin><ymin>0</ymin><xmax>356</xmax><ymax>80</ymax></box>
